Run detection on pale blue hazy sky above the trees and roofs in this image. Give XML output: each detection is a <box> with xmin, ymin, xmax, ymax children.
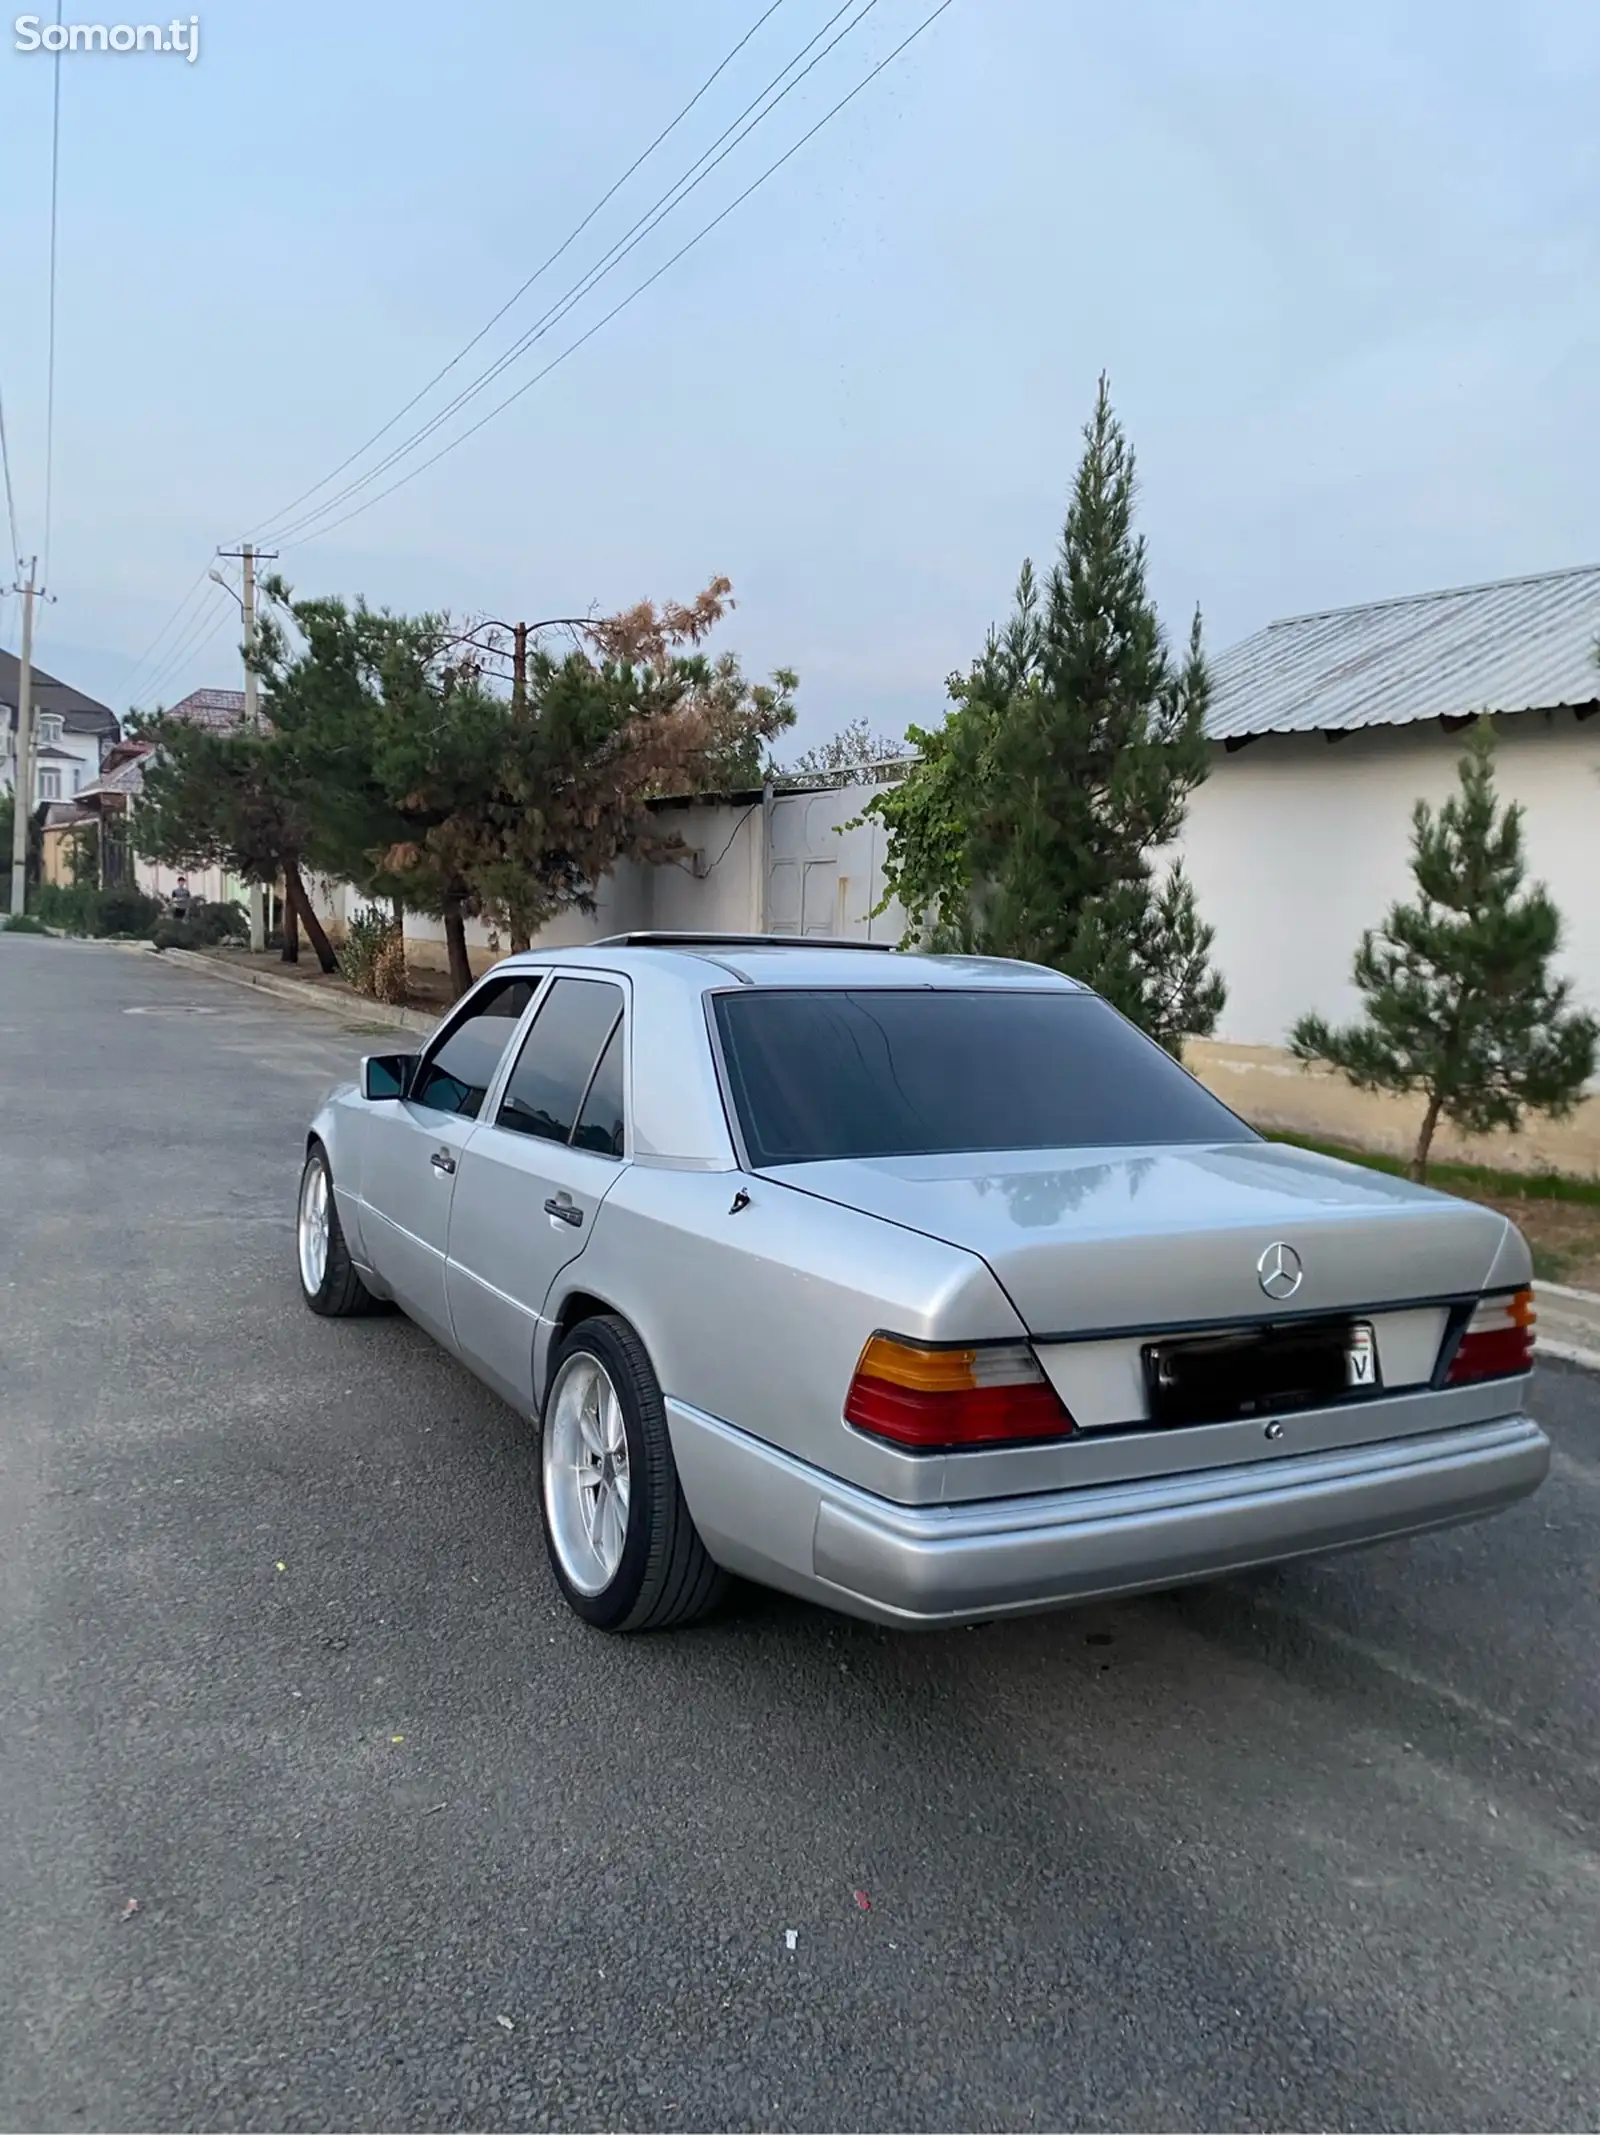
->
<box><xmin>0</xmin><ymin>0</ymin><xmax>1600</xmax><ymax>747</ymax></box>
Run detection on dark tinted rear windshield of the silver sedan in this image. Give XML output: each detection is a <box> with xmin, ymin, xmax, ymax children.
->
<box><xmin>716</xmin><ymin>986</ymin><xmax>1256</xmax><ymax>1166</ymax></box>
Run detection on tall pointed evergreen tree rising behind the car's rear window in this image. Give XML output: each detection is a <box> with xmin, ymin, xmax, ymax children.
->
<box><xmin>867</xmin><ymin>378</ymin><xmax>1224</xmax><ymax>1053</ymax></box>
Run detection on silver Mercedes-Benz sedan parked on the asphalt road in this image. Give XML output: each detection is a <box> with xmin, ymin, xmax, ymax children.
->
<box><xmin>297</xmin><ymin>935</ymin><xmax>1549</xmax><ymax>1631</ymax></box>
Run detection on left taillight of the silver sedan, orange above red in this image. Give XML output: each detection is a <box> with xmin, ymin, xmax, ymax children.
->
<box><xmin>844</xmin><ymin>1334</ymin><xmax>1072</xmax><ymax>1452</ymax></box>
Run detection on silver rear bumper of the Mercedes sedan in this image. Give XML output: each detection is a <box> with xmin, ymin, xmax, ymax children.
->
<box><xmin>666</xmin><ymin>1401</ymin><xmax>1551</xmax><ymax>1625</ymax></box>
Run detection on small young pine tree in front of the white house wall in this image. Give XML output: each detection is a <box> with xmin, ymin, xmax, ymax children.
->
<box><xmin>1290</xmin><ymin>722</ymin><xmax>1600</xmax><ymax>1179</ymax></box>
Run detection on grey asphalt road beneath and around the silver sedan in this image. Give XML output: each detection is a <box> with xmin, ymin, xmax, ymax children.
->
<box><xmin>0</xmin><ymin>937</ymin><xmax>1600</xmax><ymax>2129</ymax></box>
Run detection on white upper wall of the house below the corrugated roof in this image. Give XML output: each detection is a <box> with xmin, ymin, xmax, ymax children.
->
<box><xmin>1181</xmin><ymin>711</ymin><xmax>1600</xmax><ymax>1046</ymax></box>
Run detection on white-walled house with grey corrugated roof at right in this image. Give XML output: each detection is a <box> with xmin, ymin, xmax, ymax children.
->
<box><xmin>1183</xmin><ymin>566</ymin><xmax>1600</xmax><ymax>1170</ymax></box>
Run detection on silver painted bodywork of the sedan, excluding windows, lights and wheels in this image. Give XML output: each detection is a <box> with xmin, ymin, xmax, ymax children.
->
<box><xmin>312</xmin><ymin>942</ymin><xmax>1549</xmax><ymax>1623</ymax></box>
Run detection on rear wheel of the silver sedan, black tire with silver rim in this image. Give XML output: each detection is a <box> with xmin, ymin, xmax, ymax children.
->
<box><xmin>538</xmin><ymin>1313</ymin><xmax>728</xmax><ymax>1631</ymax></box>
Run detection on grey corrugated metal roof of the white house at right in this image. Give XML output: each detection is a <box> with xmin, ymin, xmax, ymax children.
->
<box><xmin>1205</xmin><ymin>564</ymin><xmax>1600</xmax><ymax>741</ymax></box>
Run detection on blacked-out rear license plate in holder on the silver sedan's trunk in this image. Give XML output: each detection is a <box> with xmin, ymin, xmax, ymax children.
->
<box><xmin>1143</xmin><ymin>1319</ymin><xmax>1382</xmax><ymax>1426</ymax></box>
